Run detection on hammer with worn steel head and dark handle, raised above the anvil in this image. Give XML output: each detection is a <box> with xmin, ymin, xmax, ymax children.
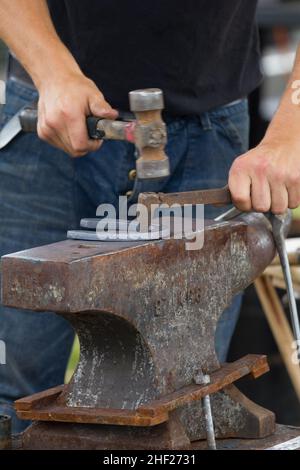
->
<box><xmin>0</xmin><ymin>88</ymin><xmax>170</xmax><ymax>179</ymax></box>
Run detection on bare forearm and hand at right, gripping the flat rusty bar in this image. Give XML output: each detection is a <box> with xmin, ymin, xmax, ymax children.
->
<box><xmin>229</xmin><ymin>48</ymin><xmax>300</xmax><ymax>214</ymax></box>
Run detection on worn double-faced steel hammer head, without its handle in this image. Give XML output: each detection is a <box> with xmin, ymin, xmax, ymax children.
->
<box><xmin>129</xmin><ymin>88</ymin><xmax>170</xmax><ymax>179</ymax></box>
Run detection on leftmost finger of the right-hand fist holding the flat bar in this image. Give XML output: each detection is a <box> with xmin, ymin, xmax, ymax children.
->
<box><xmin>228</xmin><ymin>165</ymin><xmax>252</xmax><ymax>212</ymax></box>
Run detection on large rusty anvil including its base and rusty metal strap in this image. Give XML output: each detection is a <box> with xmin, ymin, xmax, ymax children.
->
<box><xmin>2</xmin><ymin>215</ymin><xmax>275</xmax><ymax>449</ymax></box>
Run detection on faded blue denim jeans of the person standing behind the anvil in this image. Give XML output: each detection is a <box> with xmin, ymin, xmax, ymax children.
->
<box><xmin>0</xmin><ymin>81</ymin><xmax>248</xmax><ymax>432</ymax></box>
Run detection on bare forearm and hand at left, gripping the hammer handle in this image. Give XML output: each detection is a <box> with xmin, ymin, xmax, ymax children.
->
<box><xmin>0</xmin><ymin>0</ymin><xmax>118</xmax><ymax>156</ymax></box>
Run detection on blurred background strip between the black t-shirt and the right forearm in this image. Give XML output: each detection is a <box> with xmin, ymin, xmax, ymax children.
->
<box><xmin>250</xmin><ymin>0</ymin><xmax>300</xmax><ymax>147</ymax></box>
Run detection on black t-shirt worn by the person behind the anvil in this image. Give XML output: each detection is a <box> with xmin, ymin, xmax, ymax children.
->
<box><xmin>48</xmin><ymin>0</ymin><xmax>261</xmax><ymax>115</ymax></box>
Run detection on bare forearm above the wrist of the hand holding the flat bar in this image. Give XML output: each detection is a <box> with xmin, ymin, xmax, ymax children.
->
<box><xmin>263</xmin><ymin>46</ymin><xmax>300</xmax><ymax>146</ymax></box>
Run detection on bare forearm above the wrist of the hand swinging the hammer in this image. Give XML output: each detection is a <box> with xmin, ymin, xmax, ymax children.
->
<box><xmin>0</xmin><ymin>0</ymin><xmax>80</xmax><ymax>88</ymax></box>
